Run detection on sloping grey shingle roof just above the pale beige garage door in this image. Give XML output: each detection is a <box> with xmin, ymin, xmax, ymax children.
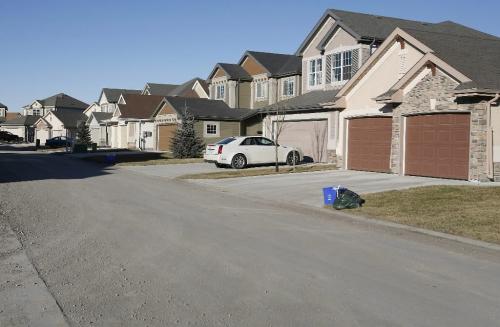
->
<box><xmin>260</xmin><ymin>90</ymin><xmax>339</xmax><ymax>112</ymax></box>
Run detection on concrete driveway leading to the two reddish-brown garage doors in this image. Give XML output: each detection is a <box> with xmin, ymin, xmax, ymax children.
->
<box><xmin>190</xmin><ymin>170</ymin><xmax>472</xmax><ymax>207</ymax></box>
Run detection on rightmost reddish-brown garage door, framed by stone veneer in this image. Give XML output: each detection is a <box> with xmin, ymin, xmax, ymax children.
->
<box><xmin>405</xmin><ymin>114</ymin><xmax>470</xmax><ymax>179</ymax></box>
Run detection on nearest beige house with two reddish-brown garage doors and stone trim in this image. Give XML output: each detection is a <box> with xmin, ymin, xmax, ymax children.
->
<box><xmin>325</xmin><ymin>22</ymin><xmax>500</xmax><ymax>181</ymax></box>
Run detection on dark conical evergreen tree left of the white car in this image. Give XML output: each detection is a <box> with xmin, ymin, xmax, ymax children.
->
<box><xmin>171</xmin><ymin>110</ymin><xmax>205</xmax><ymax>158</ymax></box>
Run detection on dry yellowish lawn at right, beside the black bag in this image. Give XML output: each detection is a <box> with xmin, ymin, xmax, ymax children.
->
<box><xmin>350</xmin><ymin>186</ymin><xmax>500</xmax><ymax>243</ymax></box>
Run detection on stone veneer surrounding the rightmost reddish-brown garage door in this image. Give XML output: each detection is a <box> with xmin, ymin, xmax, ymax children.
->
<box><xmin>390</xmin><ymin>71</ymin><xmax>488</xmax><ymax>181</ymax></box>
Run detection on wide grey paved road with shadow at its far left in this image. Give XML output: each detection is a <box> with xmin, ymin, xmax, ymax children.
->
<box><xmin>0</xmin><ymin>154</ymin><xmax>500</xmax><ymax>326</ymax></box>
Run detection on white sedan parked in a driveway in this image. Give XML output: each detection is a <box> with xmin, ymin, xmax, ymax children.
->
<box><xmin>203</xmin><ymin>136</ymin><xmax>303</xmax><ymax>169</ymax></box>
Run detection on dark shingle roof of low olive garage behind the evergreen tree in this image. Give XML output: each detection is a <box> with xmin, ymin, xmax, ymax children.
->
<box><xmin>165</xmin><ymin>97</ymin><xmax>256</xmax><ymax>121</ymax></box>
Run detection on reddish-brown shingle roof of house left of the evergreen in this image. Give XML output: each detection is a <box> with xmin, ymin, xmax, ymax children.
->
<box><xmin>118</xmin><ymin>94</ymin><xmax>164</xmax><ymax>119</ymax></box>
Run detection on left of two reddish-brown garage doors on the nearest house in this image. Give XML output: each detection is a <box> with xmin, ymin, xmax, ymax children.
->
<box><xmin>347</xmin><ymin>117</ymin><xmax>392</xmax><ymax>172</ymax></box>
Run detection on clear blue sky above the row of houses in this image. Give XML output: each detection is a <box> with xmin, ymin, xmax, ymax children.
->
<box><xmin>0</xmin><ymin>0</ymin><xmax>500</xmax><ymax>111</ymax></box>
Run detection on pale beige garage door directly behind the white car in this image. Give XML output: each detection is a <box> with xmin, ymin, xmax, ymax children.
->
<box><xmin>278</xmin><ymin>120</ymin><xmax>328</xmax><ymax>162</ymax></box>
